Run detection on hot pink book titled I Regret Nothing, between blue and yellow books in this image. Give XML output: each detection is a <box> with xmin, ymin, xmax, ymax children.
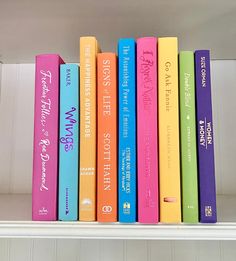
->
<box><xmin>137</xmin><ymin>37</ymin><xmax>159</xmax><ymax>224</ymax></box>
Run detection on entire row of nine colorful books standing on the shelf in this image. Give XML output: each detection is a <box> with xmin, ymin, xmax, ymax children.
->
<box><xmin>32</xmin><ymin>37</ymin><xmax>216</xmax><ymax>223</ymax></box>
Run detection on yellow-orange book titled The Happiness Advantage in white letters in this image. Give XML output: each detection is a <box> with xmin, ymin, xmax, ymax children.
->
<box><xmin>79</xmin><ymin>37</ymin><xmax>98</xmax><ymax>221</ymax></box>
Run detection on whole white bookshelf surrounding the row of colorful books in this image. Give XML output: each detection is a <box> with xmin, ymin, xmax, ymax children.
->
<box><xmin>0</xmin><ymin>0</ymin><xmax>236</xmax><ymax>261</ymax></box>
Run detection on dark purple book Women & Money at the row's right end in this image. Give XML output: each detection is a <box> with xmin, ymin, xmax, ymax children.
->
<box><xmin>195</xmin><ymin>50</ymin><xmax>216</xmax><ymax>223</ymax></box>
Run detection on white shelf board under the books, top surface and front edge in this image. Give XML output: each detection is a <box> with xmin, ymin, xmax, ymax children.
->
<box><xmin>0</xmin><ymin>194</ymin><xmax>236</xmax><ymax>240</ymax></box>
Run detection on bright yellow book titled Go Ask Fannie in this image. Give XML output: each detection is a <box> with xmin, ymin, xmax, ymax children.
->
<box><xmin>158</xmin><ymin>37</ymin><xmax>181</xmax><ymax>223</ymax></box>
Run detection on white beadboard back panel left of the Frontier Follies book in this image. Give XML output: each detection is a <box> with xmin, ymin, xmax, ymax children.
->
<box><xmin>0</xmin><ymin>64</ymin><xmax>34</xmax><ymax>193</ymax></box>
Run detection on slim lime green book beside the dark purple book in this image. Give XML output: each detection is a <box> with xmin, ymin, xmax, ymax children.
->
<box><xmin>179</xmin><ymin>51</ymin><xmax>199</xmax><ymax>223</ymax></box>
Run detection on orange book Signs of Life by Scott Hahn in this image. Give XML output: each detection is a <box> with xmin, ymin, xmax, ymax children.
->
<box><xmin>97</xmin><ymin>53</ymin><xmax>117</xmax><ymax>222</ymax></box>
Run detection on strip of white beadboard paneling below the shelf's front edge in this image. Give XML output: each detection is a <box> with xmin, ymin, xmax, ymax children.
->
<box><xmin>0</xmin><ymin>239</ymin><xmax>236</xmax><ymax>261</ymax></box>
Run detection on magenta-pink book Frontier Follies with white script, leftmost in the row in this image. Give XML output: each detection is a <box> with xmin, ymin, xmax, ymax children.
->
<box><xmin>32</xmin><ymin>54</ymin><xmax>64</xmax><ymax>221</ymax></box>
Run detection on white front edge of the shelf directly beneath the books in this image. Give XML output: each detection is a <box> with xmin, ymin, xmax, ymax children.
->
<box><xmin>0</xmin><ymin>221</ymin><xmax>236</xmax><ymax>240</ymax></box>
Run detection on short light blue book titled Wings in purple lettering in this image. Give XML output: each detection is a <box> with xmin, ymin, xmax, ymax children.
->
<box><xmin>59</xmin><ymin>64</ymin><xmax>79</xmax><ymax>221</ymax></box>
